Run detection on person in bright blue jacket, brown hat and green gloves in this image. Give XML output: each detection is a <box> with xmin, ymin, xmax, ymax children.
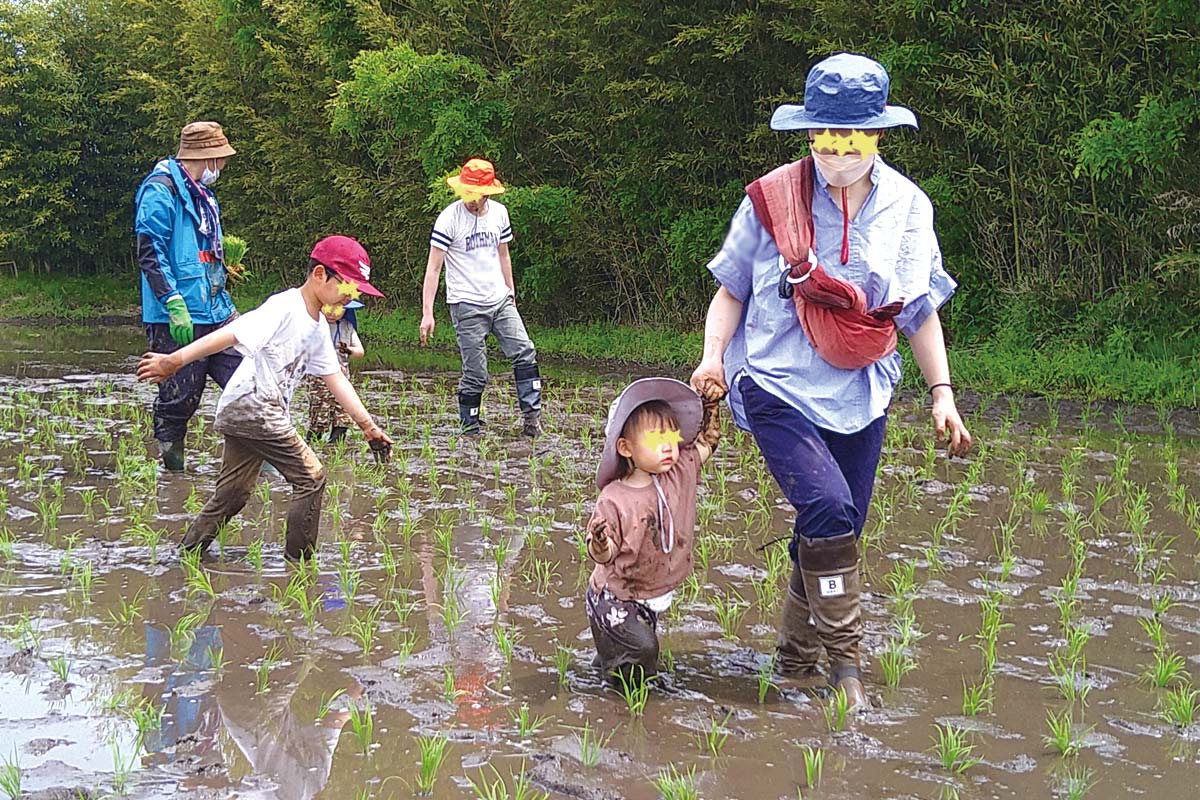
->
<box><xmin>133</xmin><ymin>122</ymin><xmax>241</xmax><ymax>473</ymax></box>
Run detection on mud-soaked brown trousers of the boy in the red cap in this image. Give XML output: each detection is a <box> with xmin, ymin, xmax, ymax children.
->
<box><xmin>184</xmin><ymin>431</ymin><xmax>325</xmax><ymax>560</ymax></box>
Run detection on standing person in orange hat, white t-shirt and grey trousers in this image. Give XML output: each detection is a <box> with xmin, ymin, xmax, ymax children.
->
<box><xmin>421</xmin><ymin>158</ymin><xmax>541</xmax><ymax>437</ymax></box>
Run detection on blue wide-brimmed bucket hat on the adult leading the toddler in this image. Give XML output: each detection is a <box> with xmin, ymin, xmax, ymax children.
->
<box><xmin>770</xmin><ymin>53</ymin><xmax>917</xmax><ymax>131</ymax></box>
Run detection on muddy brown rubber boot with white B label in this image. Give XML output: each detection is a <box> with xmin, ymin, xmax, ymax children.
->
<box><xmin>798</xmin><ymin>533</ymin><xmax>868</xmax><ymax>708</ymax></box>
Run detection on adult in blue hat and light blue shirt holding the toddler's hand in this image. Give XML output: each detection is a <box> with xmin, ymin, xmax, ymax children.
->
<box><xmin>692</xmin><ymin>53</ymin><xmax>971</xmax><ymax>706</ymax></box>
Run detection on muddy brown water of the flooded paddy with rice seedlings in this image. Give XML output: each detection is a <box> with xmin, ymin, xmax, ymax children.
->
<box><xmin>0</xmin><ymin>329</ymin><xmax>1200</xmax><ymax>800</ymax></box>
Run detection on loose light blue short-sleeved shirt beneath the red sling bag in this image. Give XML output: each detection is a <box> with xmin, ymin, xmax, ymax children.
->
<box><xmin>708</xmin><ymin>156</ymin><xmax>958</xmax><ymax>433</ymax></box>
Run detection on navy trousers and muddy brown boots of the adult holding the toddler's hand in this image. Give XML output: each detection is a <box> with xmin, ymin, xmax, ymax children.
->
<box><xmin>738</xmin><ymin>377</ymin><xmax>887</xmax><ymax>705</ymax></box>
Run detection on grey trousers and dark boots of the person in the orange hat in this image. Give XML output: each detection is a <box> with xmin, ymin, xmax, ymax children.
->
<box><xmin>450</xmin><ymin>296</ymin><xmax>541</xmax><ymax>433</ymax></box>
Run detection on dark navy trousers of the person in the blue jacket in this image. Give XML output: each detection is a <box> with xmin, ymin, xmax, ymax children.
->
<box><xmin>146</xmin><ymin>317</ymin><xmax>241</xmax><ymax>443</ymax></box>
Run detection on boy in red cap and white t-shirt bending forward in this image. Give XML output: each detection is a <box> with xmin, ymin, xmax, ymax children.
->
<box><xmin>138</xmin><ymin>236</ymin><xmax>391</xmax><ymax>561</ymax></box>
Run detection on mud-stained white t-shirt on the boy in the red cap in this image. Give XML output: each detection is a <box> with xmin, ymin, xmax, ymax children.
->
<box><xmin>212</xmin><ymin>289</ymin><xmax>341</xmax><ymax>439</ymax></box>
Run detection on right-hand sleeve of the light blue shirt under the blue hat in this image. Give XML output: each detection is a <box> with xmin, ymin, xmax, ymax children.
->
<box><xmin>895</xmin><ymin>192</ymin><xmax>959</xmax><ymax>337</ymax></box>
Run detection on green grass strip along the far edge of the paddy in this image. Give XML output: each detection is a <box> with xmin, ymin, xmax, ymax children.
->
<box><xmin>0</xmin><ymin>276</ymin><xmax>1200</xmax><ymax>409</ymax></box>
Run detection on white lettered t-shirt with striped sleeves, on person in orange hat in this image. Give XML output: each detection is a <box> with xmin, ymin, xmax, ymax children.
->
<box><xmin>430</xmin><ymin>200</ymin><xmax>512</xmax><ymax>306</ymax></box>
